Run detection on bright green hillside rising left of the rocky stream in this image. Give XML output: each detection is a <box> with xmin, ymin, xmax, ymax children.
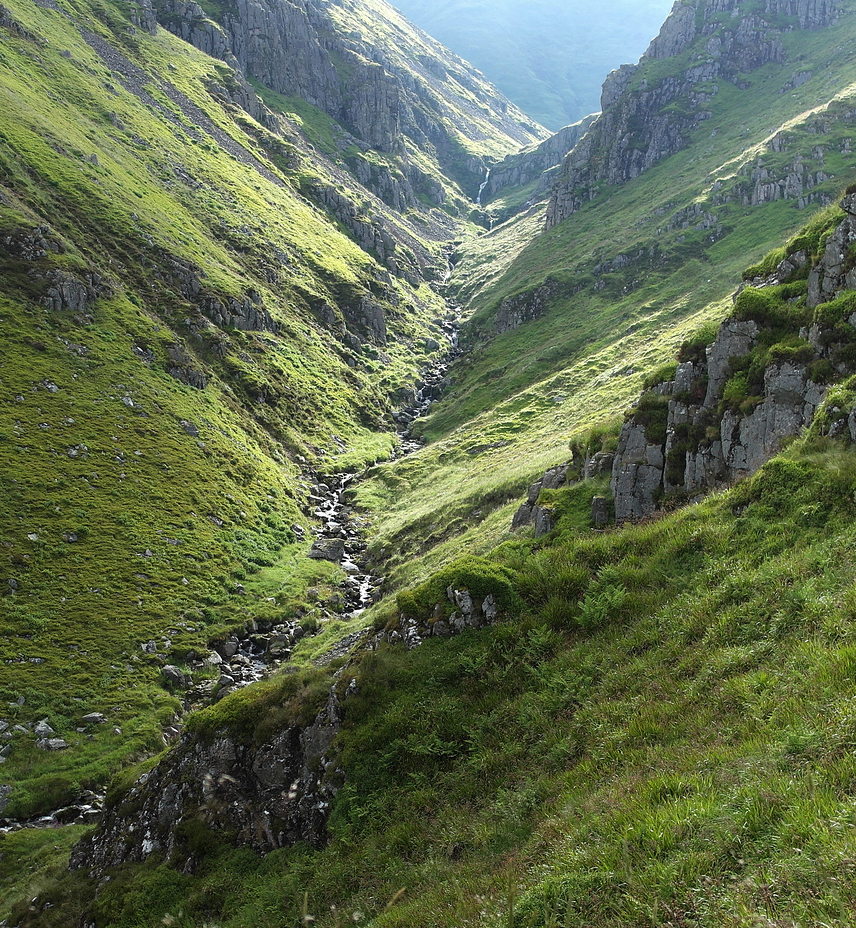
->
<box><xmin>0</xmin><ymin>0</ymin><xmax>468</xmax><ymax>815</ymax></box>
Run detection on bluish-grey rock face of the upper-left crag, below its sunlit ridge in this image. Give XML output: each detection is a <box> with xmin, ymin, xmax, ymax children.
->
<box><xmin>158</xmin><ymin>0</ymin><xmax>538</xmax><ymax>188</ymax></box>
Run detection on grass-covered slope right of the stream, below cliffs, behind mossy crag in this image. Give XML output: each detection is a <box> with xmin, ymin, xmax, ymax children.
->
<box><xmin>360</xmin><ymin>1</ymin><xmax>856</xmax><ymax>582</ymax></box>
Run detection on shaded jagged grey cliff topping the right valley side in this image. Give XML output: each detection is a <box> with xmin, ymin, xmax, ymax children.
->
<box><xmin>547</xmin><ymin>0</ymin><xmax>839</xmax><ymax>228</ymax></box>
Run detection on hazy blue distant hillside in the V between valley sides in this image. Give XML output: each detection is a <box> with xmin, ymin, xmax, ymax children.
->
<box><xmin>394</xmin><ymin>0</ymin><xmax>672</xmax><ymax>129</ymax></box>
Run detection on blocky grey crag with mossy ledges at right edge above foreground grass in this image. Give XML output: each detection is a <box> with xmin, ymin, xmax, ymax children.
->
<box><xmin>612</xmin><ymin>195</ymin><xmax>856</xmax><ymax>522</ymax></box>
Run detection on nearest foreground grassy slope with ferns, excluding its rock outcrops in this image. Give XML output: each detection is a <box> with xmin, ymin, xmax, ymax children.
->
<box><xmin>10</xmin><ymin>374</ymin><xmax>856</xmax><ymax>928</ymax></box>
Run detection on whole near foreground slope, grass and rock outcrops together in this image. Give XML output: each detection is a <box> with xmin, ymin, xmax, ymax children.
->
<box><xmin>12</xmin><ymin>203</ymin><xmax>856</xmax><ymax>928</ymax></box>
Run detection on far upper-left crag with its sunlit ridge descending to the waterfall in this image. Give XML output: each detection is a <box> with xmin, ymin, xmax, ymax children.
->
<box><xmin>156</xmin><ymin>0</ymin><xmax>546</xmax><ymax>198</ymax></box>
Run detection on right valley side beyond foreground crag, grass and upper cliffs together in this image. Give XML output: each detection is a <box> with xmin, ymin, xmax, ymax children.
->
<box><xmin>360</xmin><ymin>3</ymin><xmax>856</xmax><ymax>596</ymax></box>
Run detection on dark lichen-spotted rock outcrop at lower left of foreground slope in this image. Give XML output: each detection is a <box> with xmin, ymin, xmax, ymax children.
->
<box><xmin>71</xmin><ymin>680</ymin><xmax>356</xmax><ymax>876</ymax></box>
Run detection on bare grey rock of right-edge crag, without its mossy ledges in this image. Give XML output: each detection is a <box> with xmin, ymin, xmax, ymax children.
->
<box><xmin>608</xmin><ymin>194</ymin><xmax>856</xmax><ymax>522</ymax></box>
